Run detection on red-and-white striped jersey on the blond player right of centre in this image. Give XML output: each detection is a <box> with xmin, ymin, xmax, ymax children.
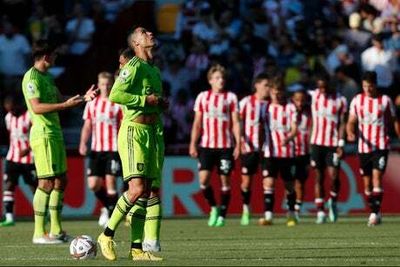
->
<box><xmin>194</xmin><ymin>90</ymin><xmax>239</xmax><ymax>148</ymax></box>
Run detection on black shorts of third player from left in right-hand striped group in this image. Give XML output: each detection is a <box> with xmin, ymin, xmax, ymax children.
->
<box><xmin>261</xmin><ymin>158</ymin><xmax>294</xmax><ymax>181</ymax></box>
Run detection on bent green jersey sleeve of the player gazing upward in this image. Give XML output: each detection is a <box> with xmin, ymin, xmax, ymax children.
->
<box><xmin>109</xmin><ymin>64</ymin><xmax>146</xmax><ymax>108</ymax></box>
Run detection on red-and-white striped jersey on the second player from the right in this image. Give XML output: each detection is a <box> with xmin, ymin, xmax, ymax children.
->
<box><xmin>309</xmin><ymin>89</ymin><xmax>347</xmax><ymax>147</ymax></box>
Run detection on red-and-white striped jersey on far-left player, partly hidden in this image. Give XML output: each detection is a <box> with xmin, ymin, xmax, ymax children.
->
<box><xmin>5</xmin><ymin>111</ymin><xmax>33</xmax><ymax>164</ymax></box>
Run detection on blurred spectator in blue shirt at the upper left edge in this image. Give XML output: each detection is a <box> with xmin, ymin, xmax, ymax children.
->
<box><xmin>0</xmin><ymin>20</ymin><xmax>31</xmax><ymax>100</ymax></box>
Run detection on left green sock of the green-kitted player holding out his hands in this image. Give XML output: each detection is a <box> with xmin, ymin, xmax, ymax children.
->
<box><xmin>33</xmin><ymin>188</ymin><xmax>50</xmax><ymax>237</ymax></box>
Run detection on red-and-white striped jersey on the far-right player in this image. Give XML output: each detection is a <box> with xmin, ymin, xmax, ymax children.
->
<box><xmin>350</xmin><ymin>94</ymin><xmax>396</xmax><ymax>153</ymax></box>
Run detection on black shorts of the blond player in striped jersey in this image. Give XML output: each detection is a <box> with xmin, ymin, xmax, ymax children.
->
<box><xmin>199</xmin><ymin>148</ymin><xmax>234</xmax><ymax>175</ymax></box>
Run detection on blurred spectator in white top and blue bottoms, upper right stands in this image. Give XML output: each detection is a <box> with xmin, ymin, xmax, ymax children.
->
<box><xmin>361</xmin><ymin>35</ymin><xmax>396</xmax><ymax>90</ymax></box>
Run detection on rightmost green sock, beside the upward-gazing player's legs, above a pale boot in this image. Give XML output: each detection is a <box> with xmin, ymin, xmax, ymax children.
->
<box><xmin>144</xmin><ymin>196</ymin><xmax>162</xmax><ymax>243</ymax></box>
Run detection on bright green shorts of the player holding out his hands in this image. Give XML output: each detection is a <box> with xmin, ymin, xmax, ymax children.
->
<box><xmin>30</xmin><ymin>137</ymin><xmax>67</xmax><ymax>179</ymax></box>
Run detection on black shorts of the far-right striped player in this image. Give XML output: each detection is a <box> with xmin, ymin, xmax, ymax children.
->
<box><xmin>358</xmin><ymin>150</ymin><xmax>389</xmax><ymax>176</ymax></box>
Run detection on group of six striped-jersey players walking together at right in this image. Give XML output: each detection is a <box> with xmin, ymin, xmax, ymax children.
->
<box><xmin>189</xmin><ymin>65</ymin><xmax>400</xmax><ymax>227</ymax></box>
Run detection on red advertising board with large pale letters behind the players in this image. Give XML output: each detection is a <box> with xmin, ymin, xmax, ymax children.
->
<box><xmin>0</xmin><ymin>152</ymin><xmax>400</xmax><ymax>217</ymax></box>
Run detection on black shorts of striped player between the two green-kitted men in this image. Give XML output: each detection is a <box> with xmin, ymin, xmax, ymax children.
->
<box><xmin>87</xmin><ymin>151</ymin><xmax>121</xmax><ymax>177</ymax></box>
